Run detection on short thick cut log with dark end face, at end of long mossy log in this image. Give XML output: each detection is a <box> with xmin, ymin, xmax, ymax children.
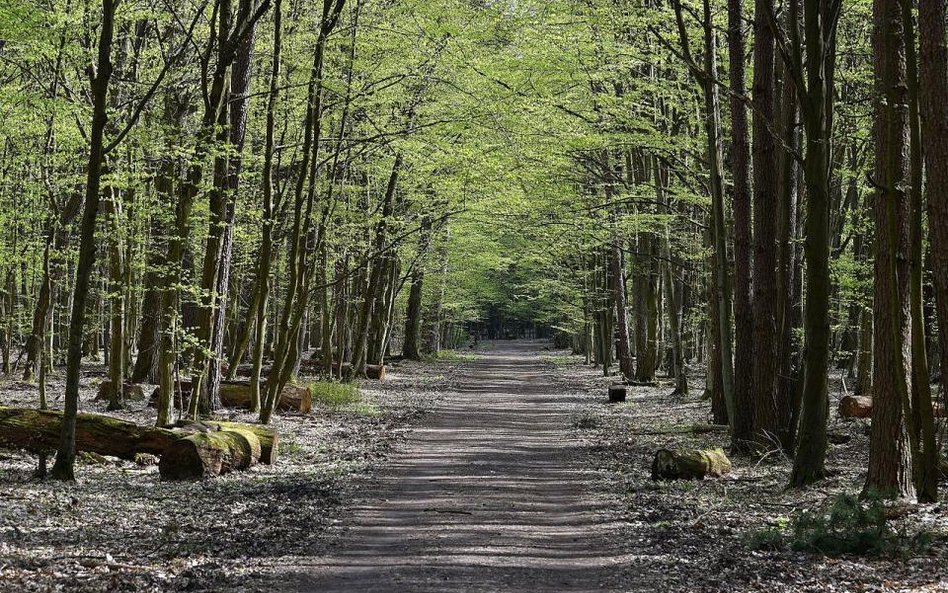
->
<box><xmin>158</xmin><ymin>429</ymin><xmax>260</xmax><ymax>480</ymax></box>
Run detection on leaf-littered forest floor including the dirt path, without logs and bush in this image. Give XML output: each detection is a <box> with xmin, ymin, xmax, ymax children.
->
<box><xmin>0</xmin><ymin>342</ymin><xmax>948</xmax><ymax>593</ymax></box>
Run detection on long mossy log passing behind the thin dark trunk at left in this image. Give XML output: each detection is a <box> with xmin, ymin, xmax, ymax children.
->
<box><xmin>0</xmin><ymin>408</ymin><xmax>181</xmax><ymax>461</ymax></box>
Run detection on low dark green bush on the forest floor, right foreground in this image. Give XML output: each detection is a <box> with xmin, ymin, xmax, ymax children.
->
<box><xmin>745</xmin><ymin>494</ymin><xmax>931</xmax><ymax>556</ymax></box>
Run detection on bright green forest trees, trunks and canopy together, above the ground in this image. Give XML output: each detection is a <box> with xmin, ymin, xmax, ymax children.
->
<box><xmin>0</xmin><ymin>0</ymin><xmax>948</xmax><ymax>508</ymax></box>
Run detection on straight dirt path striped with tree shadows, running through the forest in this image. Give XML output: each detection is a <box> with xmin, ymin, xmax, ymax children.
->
<box><xmin>274</xmin><ymin>342</ymin><xmax>627</xmax><ymax>593</ymax></box>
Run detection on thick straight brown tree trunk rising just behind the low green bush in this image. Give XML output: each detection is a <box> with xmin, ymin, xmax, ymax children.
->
<box><xmin>864</xmin><ymin>0</ymin><xmax>915</xmax><ymax>498</ymax></box>
